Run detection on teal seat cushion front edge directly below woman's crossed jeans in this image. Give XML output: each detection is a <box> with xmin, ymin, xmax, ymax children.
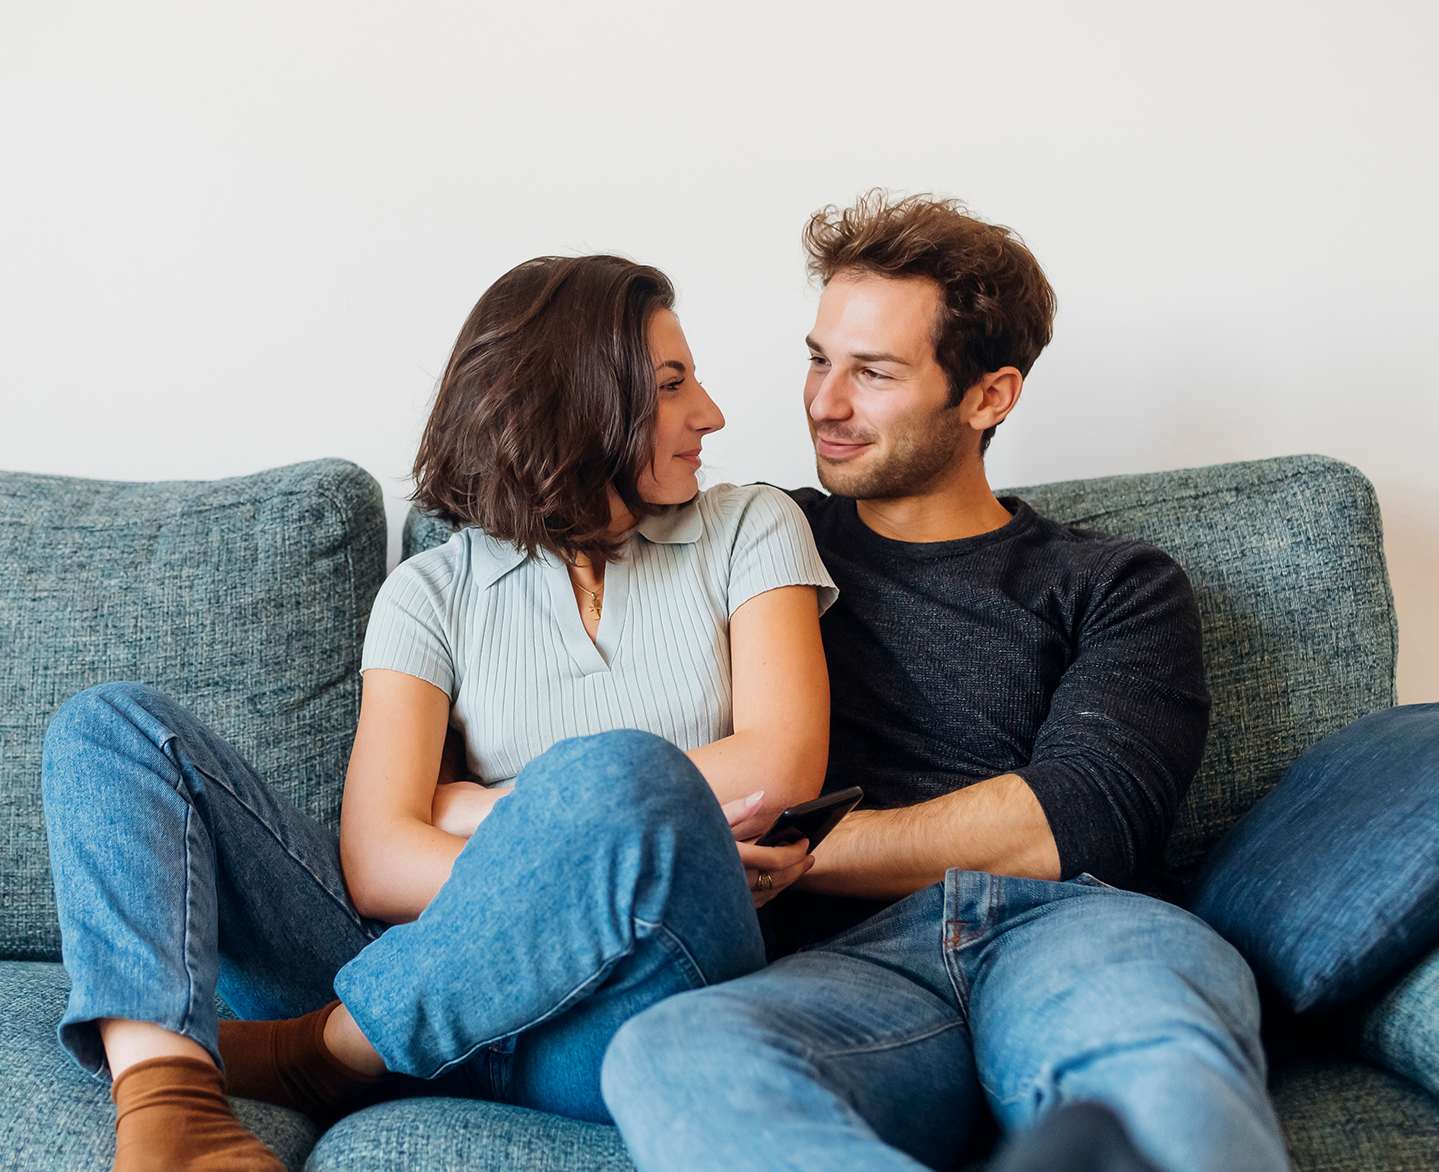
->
<box><xmin>305</xmin><ymin>1099</ymin><xmax>635</xmax><ymax>1172</ymax></box>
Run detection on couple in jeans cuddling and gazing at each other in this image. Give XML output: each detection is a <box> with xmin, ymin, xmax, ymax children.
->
<box><xmin>43</xmin><ymin>194</ymin><xmax>1427</xmax><ymax>1172</ymax></box>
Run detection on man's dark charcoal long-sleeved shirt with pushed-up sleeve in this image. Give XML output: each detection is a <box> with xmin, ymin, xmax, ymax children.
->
<box><xmin>790</xmin><ymin>488</ymin><xmax>1209</xmax><ymax>927</ymax></box>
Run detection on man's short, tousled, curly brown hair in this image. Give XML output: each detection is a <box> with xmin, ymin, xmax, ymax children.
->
<box><xmin>804</xmin><ymin>189</ymin><xmax>1055</xmax><ymax>454</ymax></box>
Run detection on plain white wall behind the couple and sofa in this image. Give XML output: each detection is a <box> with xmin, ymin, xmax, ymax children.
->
<box><xmin>0</xmin><ymin>0</ymin><xmax>1439</xmax><ymax>703</ymax></box>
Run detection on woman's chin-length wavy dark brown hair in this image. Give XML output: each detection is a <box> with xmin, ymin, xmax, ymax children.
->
<box><xmin>412</xmin><ymin>256</ymin><xmax>675</xmax><ymax>562</ymax></box>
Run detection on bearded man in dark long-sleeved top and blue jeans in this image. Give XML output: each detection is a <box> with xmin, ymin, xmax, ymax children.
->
<box><xmin>604</xmin><ymin>193</ymin><xmax>1288</xmax><ymax>1172</ymax></box>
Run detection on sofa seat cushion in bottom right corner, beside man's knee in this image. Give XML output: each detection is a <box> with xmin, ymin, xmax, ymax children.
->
<box><xmin>1269</xmin><ymin>1047</ymin><xmax>1439</xmax><ymax>1172</ymax></box>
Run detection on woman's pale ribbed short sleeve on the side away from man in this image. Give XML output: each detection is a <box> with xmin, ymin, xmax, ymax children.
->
<box><xmin>360</xmin><ymin>546</ymin><xmax>459</xmax><ymax>700</ymax></box>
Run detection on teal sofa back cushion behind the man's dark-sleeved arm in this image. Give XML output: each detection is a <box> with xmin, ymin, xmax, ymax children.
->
<box><xmin>1003</xmin><ymin>456</ymin><xmax>1399</xmax><ymax>871</ymax></box>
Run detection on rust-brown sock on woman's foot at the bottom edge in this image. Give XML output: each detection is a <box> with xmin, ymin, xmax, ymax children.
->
<box><xmin>109</xmin><ymin>1058</ymin><xmax>285</xmax><ymax>1172</ymax></box>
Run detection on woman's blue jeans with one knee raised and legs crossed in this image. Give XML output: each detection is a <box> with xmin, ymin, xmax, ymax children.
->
<box><xmin>42</xmin><ymin>684</ymin><xmax>764</xmax><ymax>1122</ymax></box>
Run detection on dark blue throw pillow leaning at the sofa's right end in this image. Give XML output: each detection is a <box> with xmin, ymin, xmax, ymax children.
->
<box><xmin>1190</xmin><ymin>704</ymin><xmax>1439</xmax><ymax>1014</ymax></box>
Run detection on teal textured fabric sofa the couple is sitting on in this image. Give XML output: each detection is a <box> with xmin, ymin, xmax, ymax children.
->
<box><xmin>0</xmin><ymin>456</ymin><xmax>1439</xmax><ymax>1172</ymax></box>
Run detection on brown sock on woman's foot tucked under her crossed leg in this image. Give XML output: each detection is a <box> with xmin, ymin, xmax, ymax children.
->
<box><xmin>220</xmin><ymin>1001</ymin><xmax>386</xmax><ymax>1127</ymax></box>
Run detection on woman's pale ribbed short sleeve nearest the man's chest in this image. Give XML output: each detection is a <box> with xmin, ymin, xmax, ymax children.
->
<box><xmin>727</xmin><ymin>484</ymin><xmax>839</xmax><ymax>615</ymax></box>
